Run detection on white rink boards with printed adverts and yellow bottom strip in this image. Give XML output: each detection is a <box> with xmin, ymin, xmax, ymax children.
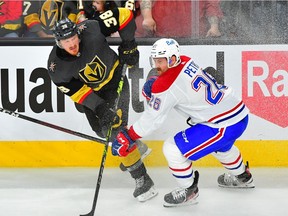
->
<box><xmin>0</xmin><ymin>45</ymin><xmax>288</xmax><ymax>167</ymax></box>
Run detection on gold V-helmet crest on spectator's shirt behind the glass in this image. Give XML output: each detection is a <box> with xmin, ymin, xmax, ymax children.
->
<box><xmin>40</xmin><ymin>0</ymin><xmax>64</xmax><ymax>30</ymax></box>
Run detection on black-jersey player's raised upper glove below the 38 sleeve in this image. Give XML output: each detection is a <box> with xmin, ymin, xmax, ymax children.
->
<box><xmin>118</xmin><ymin>40</ymin><xmax>139</xmax><ymax>67</ymax></box>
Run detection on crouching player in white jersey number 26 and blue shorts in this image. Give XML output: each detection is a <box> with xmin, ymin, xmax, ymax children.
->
<box><xmin>112</xmin><ymin>38</ymin><xmax>255</xmax><ymax>207</ymax></box>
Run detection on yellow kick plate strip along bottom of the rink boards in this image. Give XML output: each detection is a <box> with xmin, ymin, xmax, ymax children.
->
<box><xmin>0</xmin><ymin>140</ymin><xmax>288</xmax><ymax>167</ymax></box>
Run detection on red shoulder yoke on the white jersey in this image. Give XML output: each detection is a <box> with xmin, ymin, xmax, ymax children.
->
<box><xmin>152</xmin><ymin>56</ymin><xmax>191</xmax><ymax>93</ymax></box>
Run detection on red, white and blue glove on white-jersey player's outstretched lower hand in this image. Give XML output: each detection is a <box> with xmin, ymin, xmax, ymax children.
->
<box><xmin>112</xmin><ymin>129</ymin><xmax>137</xmax><ymax>157</ymax></box>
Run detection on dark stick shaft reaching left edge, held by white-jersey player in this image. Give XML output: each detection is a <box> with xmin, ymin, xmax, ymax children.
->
<box><xmin>0</xmin><ymin>107</ymin><xmax>106</xmax><ymax>144</ymax></box>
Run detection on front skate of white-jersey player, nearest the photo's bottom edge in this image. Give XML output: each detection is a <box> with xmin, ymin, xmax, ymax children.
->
<box><xmin>163</xmin><ymin>171</ymin><xmax>199</xmax><ymax>207</ymax></box>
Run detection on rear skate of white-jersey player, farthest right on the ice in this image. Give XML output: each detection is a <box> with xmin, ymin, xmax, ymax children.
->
<box><xmin>218</xmin><ymin>162</ymin><xmax>255</xmax><ymax>188</ymax></box>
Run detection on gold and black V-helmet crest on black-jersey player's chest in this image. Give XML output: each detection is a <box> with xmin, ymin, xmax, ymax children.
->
<box><xmin>79</xmin><ymin>56</ymin><xmax>106</xmax><ymax>84</ymax></box>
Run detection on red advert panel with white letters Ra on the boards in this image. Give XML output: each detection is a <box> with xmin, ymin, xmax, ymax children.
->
<box><xmin>242</xmin><ymin>51</ymin><xmax>288</xmax><ymax>128</ymax></box>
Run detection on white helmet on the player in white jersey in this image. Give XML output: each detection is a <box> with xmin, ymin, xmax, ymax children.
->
<box><xmin>150</xmin><ymin>38</ymin><xmax>181</xmax><ymax>68</ymax></box>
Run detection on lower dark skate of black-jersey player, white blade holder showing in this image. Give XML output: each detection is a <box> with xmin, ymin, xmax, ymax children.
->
<box><xmin>133</xmin><ymin>173</ymin><xmax>158</xmax><ymax>202</ymax></box>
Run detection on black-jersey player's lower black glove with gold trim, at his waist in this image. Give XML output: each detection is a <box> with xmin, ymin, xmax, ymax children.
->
<box><xmin>95</xmin><ymin>103</ymin><xmax>122</xmax><ymax>131</ymax></box>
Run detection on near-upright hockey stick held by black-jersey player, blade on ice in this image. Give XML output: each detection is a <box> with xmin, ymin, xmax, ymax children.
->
<box><xmin>80</xmin><ymin>64</ymin><xmax>127</xmax><ymax>216</ymax></box>
